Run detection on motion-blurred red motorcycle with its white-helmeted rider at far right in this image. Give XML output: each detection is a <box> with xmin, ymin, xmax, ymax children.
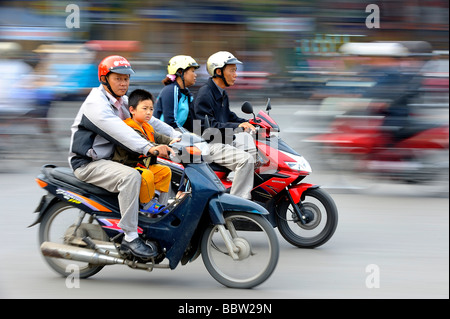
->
<box><xmin>307</xmin><ymin>41</ymin><xmax>449</xmax><ymax>196</ymax></box>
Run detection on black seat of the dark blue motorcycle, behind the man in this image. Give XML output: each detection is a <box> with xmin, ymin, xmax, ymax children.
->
<box><xmin>45</xmin><ymin>166</ymin><xmax>117</xmax><ymax>196</ymax></box>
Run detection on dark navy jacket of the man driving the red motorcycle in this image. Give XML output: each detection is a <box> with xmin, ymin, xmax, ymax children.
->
<box><xmin>194</xmin><ymin>78</ymin><xmax>247</xmax><ymax>142</ymax></box>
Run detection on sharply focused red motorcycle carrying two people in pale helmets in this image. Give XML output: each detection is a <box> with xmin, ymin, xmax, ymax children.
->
<box><xmin>163</xmin><ymin>100</ymin><xmax>338</xmax><ymax>248</ymax></box>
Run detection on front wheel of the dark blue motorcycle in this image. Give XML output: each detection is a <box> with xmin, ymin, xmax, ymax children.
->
<box><xmin>201</xmin><ymin>212</ymin><xmax>280</xmax><ymax>289</ymax></box>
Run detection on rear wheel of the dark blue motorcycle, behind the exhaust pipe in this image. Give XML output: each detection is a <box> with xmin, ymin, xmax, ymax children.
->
<box><xmin>39</xmin><ymin>202</ymin><xmax>108</xmax><ymax>278</ymax></box>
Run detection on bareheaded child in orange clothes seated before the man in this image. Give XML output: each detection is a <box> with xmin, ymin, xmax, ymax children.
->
<box><xmin>112</xmin><ymin>89</ymin><xmax>179</xmax><ymax>214</ymax></box>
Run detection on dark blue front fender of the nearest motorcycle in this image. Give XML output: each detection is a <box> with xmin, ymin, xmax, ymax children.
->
<box><xmin>209</xmin><ymin>193</ymin><xmax>269</xmax><ymax>225</ymax></box>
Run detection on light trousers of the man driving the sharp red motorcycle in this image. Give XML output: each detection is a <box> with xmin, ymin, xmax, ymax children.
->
<box><xmin>205</xmin><ymin>143</ymin><xmax>255</xmax><ymax>199</ymax></box>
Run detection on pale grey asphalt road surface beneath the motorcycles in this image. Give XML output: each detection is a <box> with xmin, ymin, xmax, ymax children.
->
<box><xmin>0</xmin><ymin>168</ymin><xmax>449</xmax><ymax>300</ymax></box>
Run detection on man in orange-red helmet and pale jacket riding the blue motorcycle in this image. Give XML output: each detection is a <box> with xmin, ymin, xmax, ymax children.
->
<box><xmin>69</xmin><ymin>55</ymin><xmax>168</xmax><ymax>258</ymax></box>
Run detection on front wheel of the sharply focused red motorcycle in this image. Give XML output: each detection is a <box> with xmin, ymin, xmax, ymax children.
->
<box><xmin>277</xmin><ymin>188</ymin><xmax>338</xmax><ymax>248</ymax></box>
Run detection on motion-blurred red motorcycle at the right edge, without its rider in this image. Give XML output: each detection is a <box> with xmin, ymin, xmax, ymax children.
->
<box><xmin>308</xmin><ymin>107</ymin><xmax>449</xmax><ymax>193</ymax></box>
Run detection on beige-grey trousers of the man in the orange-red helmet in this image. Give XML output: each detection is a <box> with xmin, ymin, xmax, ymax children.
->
<box><xmin>74</xmin><ymin>159</ymin><xmax>141</xmax><ymax>233</ymax></box>
